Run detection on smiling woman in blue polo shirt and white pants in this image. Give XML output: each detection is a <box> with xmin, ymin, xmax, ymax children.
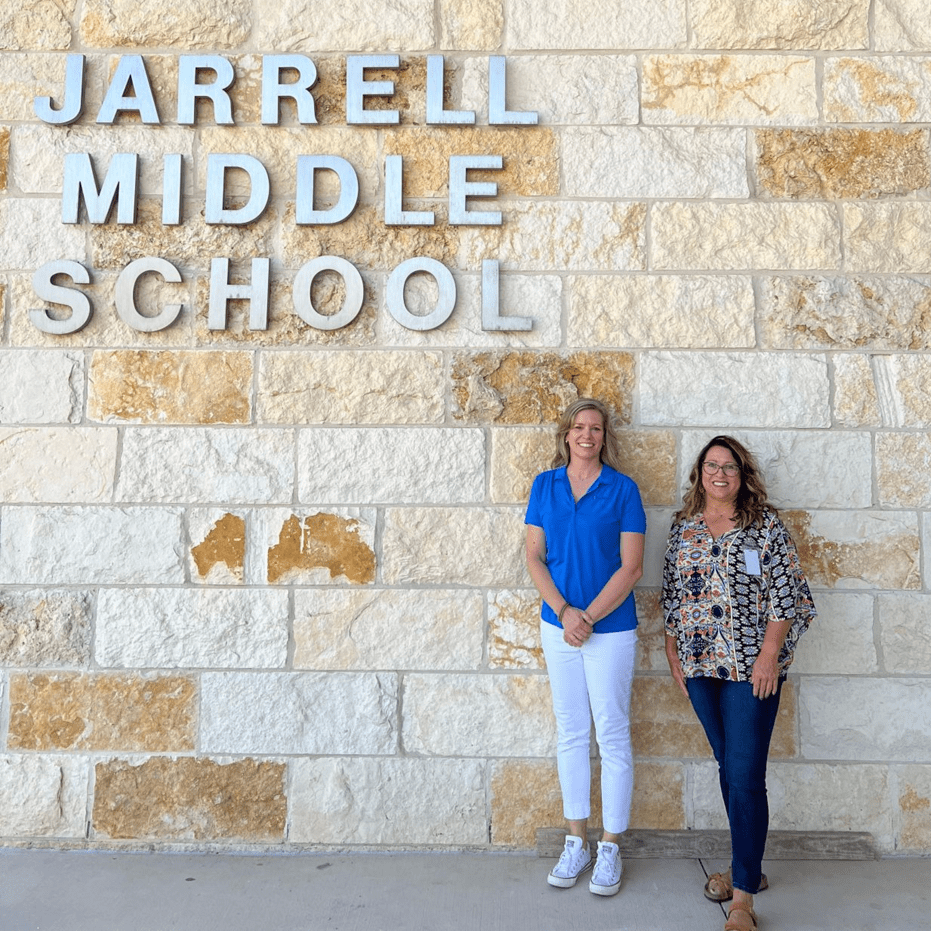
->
<box><xmin>524</xmin><ymin>398</ymin><xmax>646</xmax><ymax>895</ymax></box>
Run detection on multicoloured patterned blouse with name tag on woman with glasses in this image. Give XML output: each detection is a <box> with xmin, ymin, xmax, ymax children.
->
<box><xmin>663</xmin><ymin>510</ymin><xmax>816</xmax><ymax>682</ymax></box>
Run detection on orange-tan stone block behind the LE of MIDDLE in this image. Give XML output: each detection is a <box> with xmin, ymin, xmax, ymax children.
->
<box><xmin>384</xmin><ymin>126</ymin><xmax>559</xmax><ymax>198</ymax></box>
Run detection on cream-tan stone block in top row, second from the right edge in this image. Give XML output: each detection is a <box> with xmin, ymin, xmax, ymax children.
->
<box><xmin>689</xmin><ymin>0</ymin><xmax>870</xmax><ymax>49</ymax></box>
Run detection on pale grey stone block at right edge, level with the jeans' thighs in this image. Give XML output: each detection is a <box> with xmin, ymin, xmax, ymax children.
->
<box><xmin>799</xmin><ymin>676</ymin><xmax>931</xmax><ymax>763</ymax></box>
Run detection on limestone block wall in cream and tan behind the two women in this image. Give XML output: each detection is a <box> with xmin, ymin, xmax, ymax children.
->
<box><xmin>0</xmin><ymin>0</ymin><xmax>931</xmax><ymax>855</ymax></box>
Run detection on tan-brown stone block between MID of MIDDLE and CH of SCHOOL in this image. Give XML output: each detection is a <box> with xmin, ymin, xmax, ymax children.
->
<box><xmin>90</xmin><ymin>200</ymin><xmax>277</xmax><ymax>274</ymax></box>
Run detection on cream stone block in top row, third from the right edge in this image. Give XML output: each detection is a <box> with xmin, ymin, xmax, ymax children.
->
<box><xmin>507</xmin><ymin>0</ymin><xmax>687</xmax><ymax>51</ymax></box>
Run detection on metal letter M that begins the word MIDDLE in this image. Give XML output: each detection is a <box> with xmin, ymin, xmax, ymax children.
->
<box><xmin>61</xmin><ymin>152</ymin><xmax>139</xmax><ymax>224</ymax></box>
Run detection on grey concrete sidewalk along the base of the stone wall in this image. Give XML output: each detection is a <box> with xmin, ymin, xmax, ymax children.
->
<box><xmin>0</xmin><ymin>848</ymin><xmax>931</xmax><ymax>931</ymax></box>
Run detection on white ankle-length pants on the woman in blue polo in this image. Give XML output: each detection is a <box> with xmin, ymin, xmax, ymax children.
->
<box><xmin>540</xmin><ymin>621</ymin><xmax>637</xmax><ymax>834</ymax></box>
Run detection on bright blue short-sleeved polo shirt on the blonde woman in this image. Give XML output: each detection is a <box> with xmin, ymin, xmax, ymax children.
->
<box><xmin>524</xmin><ymin>464</ymin><xmax>647</xmax><ymax>634</ymax></box>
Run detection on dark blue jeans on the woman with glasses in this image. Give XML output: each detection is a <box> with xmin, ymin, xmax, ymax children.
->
<box><xmin>685</xmin><ymin>676</ymin><xmax>782</xmax><ymax>895</ymax></box>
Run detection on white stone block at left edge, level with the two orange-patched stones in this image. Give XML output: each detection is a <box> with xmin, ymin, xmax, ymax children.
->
<box><xmin>0</xmin><ymin>507</ymin><xmax>184</xmax><ymax>586</ymax></box>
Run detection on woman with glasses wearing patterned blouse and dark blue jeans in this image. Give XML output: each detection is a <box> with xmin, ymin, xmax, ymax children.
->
<box><xmin>663</xmin><ymin>436</ymin><xmax>815</xmax><ymax>931</ymax></box>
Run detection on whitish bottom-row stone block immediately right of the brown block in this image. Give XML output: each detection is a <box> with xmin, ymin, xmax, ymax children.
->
<box><xmin>288</xmin><ymin>757</ymin><xmax>488</xmax><ymax>847</ymax></box>
